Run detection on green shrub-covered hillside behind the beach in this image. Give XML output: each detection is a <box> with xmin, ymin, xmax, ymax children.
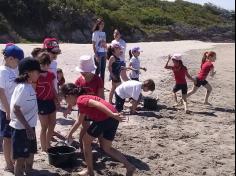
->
<box><xmin>0</xmin><ymin>0</ymin><xmax>235</xmax><ymax>43</ymax></box>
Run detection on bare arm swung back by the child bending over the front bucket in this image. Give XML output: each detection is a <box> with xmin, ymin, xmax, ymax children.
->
<box><xmin>88</xmin><ymin>100</ymin><xmax>125</xmax><ymax>122</ymax></box>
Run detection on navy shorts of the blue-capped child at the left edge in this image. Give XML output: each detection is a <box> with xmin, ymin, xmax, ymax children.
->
<box><xmin>0</xmin><ymin>110</ymin><xmax>12</xmax><ymax>138</ymax></box>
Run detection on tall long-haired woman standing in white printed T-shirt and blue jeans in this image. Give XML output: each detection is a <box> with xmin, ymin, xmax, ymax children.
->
<box><xmin>92</xmin><ymin>18</ymin><xmax>107</xmax><ymax>82</ymax></box>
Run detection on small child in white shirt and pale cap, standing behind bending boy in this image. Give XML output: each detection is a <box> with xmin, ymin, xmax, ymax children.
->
<box><xmin>129</xmin><ymin>47</ymin><xmax>147</xmax><ymax>81</ymax></box>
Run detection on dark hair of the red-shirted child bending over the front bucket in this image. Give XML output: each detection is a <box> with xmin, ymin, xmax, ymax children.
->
<box><xmin>61</xmin><ymin>83</ymin><xmax>86</xmax><ymax>97</ymax></box>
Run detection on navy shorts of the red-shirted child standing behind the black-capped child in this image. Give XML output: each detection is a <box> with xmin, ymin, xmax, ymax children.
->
<box><xmin>37</xmin><ymin>99</ymin><xmax>56</xmax><ymax>115</ymax></box>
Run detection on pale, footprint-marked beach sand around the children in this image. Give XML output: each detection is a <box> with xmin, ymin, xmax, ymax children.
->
<box><xmin>0</xmin><ymin>41</ymin><xmax>235</xmax><ymax>176</ymax></box>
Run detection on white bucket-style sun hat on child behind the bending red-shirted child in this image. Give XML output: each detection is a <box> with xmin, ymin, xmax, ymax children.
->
<box><xmin>75</xmin><ymin>55</ymin><xmax>97</xmax><ymax>73</ymax></box>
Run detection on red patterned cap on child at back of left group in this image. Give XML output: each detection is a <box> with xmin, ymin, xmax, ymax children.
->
<box><xmin>43</xmin><ymin>38</ymin><xmax>61</xmax><ymax>54</ymax></box>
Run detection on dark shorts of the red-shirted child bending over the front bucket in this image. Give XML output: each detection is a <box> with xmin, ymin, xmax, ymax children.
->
<box><xmin>87</xmin><ymin>118</ymin><xmax>119</xmax><ymax>141</ymax></box>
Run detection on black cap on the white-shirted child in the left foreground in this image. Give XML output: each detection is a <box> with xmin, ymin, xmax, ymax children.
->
<box><xmin>18</xmin><ymin>57</ymin><xmax>41</xmax><ymax>75</ymax></box>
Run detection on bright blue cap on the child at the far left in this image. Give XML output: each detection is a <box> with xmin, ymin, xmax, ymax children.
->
<box><xmin>3</xmin><ymin>45</ymin><xmax>24</xmax><ymax>60</ymax></box>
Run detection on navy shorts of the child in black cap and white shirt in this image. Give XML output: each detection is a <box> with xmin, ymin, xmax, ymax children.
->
<box><xmin>12</xmin><ymin>128</ymin><xmax>37</xmax><ymax>160</ymax></box>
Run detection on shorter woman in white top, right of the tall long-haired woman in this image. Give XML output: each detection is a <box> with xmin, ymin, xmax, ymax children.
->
<box><xmin>111</xmin><ymin>29</ymin><xmax>129</xmax><ymax>81</ymax></box>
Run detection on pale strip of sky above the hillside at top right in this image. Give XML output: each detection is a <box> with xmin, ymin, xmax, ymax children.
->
<box><xmin>163</xmin><ymin>0</ymin><xmax>235</xmax><ymax>10</ymax></box>
